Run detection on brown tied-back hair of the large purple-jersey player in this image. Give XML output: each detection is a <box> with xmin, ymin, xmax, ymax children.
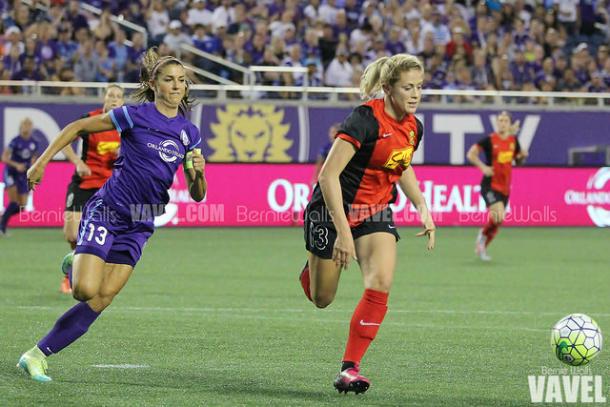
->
<box><xmin>132</xmin><ymin>47</ymin><xmax>193</xmax><ymax>116</ymax></box>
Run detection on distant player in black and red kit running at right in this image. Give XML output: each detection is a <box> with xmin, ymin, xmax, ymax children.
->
<box><xmin>466</xmin><ymin>111</ymin><xmax>527</xmax><ymax>261</ymax></box>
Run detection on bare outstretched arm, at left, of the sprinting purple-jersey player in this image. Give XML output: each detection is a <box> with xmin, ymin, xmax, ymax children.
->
<box><xmin>27</xmin><ymin>113</ymin><xmax>114</xmax><ymax>189</ymax></box>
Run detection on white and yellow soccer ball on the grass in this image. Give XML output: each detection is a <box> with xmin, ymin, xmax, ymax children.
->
<box><xmin>551</xmin><ymin>314</ymin><xmax>602</xmax><ymax>366</ymax></box>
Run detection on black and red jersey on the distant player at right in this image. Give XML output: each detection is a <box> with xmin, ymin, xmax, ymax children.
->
<box><xmin>477</xmin><ymin>133</ymin><xmax>521</xmax><ymax>196</ymax></box>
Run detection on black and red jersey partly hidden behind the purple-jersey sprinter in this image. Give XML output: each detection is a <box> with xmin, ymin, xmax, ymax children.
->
<box><xmin>72</xmin><ymin>109</ymin><xmax>121</xmax><ymax>189</ymax></box>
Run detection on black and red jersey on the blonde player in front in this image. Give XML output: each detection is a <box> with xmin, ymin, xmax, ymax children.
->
<box><xmin>309</xmin><ymin>99</ymin><xmax>424</xmax><ymax>227</ymax></box>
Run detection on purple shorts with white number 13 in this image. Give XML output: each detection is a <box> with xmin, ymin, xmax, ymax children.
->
<box><xmin>75</xmin><ymin>195</ymin><xmax>155</xmax><ymax>267</ymax></box>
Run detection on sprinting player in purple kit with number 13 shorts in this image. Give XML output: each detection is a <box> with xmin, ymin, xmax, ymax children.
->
<box><xmin>18</xmin><ymin>49</ymin><xmax>207</xmax><ymax>382</ymax></box>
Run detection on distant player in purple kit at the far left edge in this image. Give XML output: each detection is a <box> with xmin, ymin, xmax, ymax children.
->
<box><xmin>0</xmin><ymin>119</ymin><xmax>38</xmax><ymax>234</ymax></box>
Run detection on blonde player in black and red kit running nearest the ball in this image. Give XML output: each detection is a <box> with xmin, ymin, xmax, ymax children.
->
<box><xmin>300</xmin><ymin>54</ymin><xmax>436</xmax><ymax>393</ymax></box>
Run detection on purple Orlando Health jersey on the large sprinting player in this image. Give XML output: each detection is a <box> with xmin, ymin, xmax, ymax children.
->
<box><xmin>103</xmin><ymin>102</ymin><xmax>201</xmax><ymax>221</ymax></box>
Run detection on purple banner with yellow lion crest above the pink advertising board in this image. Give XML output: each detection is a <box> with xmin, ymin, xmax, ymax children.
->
<box><xmin>0</xmin><ymin>102</ymin><xmax>610</xmax><ymax>165</ymax></box>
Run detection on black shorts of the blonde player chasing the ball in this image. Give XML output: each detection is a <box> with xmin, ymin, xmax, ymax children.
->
<box><xmin>304</xmin><ymin>206</ymin><xmax>400</xmax><ymax>259</ymax></box>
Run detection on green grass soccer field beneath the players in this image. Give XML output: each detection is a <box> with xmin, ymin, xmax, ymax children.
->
<box><xmin>0</xmin><ymin>228</ymin><xmax>610</xmax><ymax>406</ymax></box>
